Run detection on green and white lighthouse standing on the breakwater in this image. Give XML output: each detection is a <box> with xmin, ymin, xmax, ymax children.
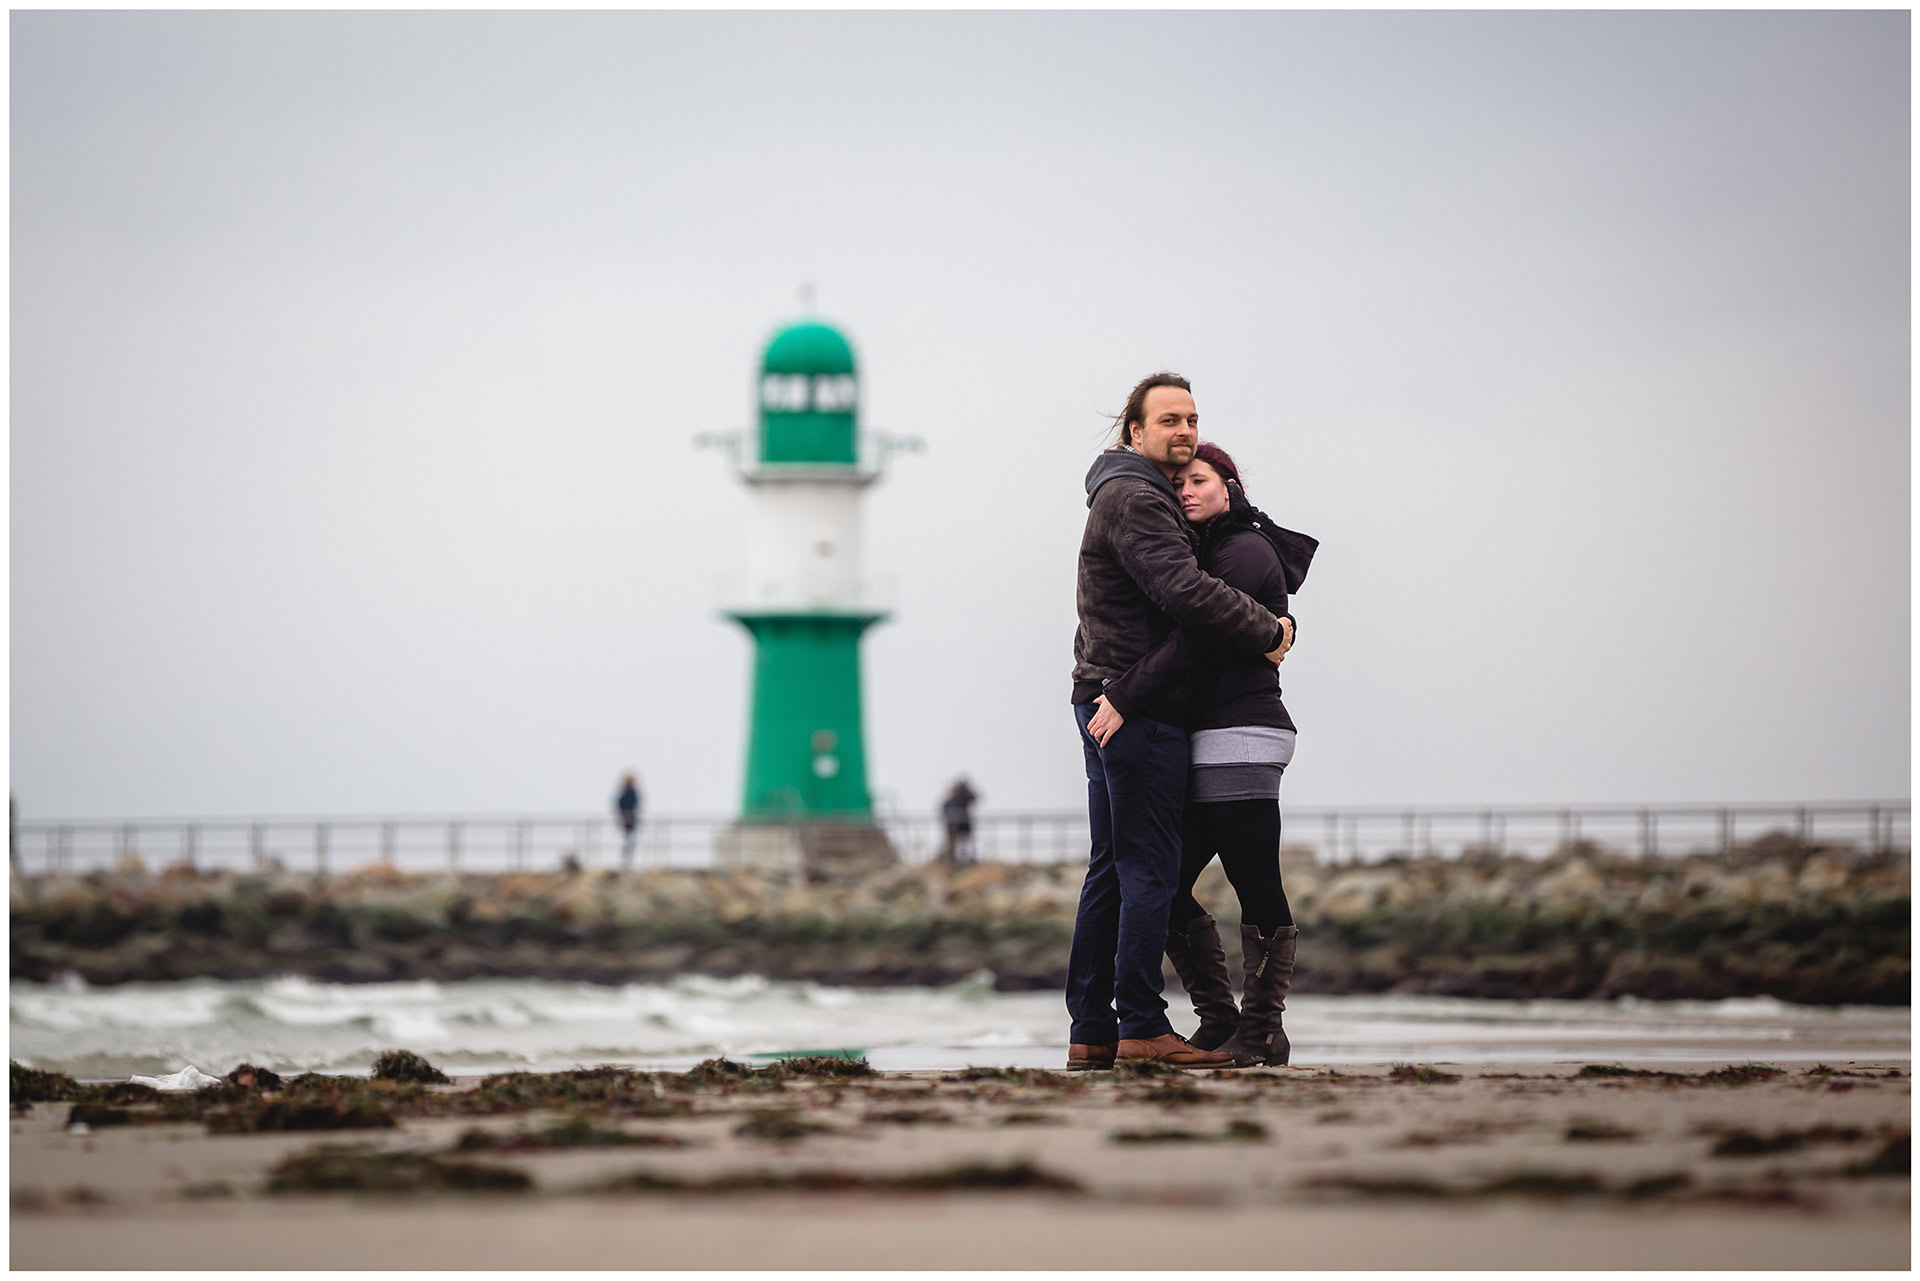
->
<box><xmin>716</xmin><ymin>321</ymin><xmax>918</xmax><ymax>868</ymax></box>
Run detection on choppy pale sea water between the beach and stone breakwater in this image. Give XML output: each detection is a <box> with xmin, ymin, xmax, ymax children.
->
<box><xmin>8</xmin><ymin>972</ymin><xmax>1912</xmax><ymax>1079</ymax></box>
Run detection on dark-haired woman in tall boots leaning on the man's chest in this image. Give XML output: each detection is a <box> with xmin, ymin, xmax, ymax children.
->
<box><xmin>1087</xmin><ymin>442</ymin><xmax>1319</xmax><ymax>1068</ymax></box>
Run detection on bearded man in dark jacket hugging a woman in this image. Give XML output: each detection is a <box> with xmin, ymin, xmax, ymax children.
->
<box><xmin>1068</xmin><ymin>373</ymin><xmax>1292</xmax><ymax>1072</ymax></box>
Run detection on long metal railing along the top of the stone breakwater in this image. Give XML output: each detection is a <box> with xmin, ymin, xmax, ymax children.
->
<box><xmin>10</xmin><ymin>801</ymin><xmax>1912</xmax><ymax>872</ymax></box>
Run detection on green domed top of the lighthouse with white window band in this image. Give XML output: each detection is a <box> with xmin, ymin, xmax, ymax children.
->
<box><xmin>758</xmin><ymin>321</ymin><xmax>860</xmax><ymax>467</ymax></box>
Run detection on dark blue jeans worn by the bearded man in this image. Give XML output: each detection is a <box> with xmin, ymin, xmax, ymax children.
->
<box><xmin>1068</xmin><ymin>703</ymin><xmax>1187</xmax><ymax>1045</ymax></box>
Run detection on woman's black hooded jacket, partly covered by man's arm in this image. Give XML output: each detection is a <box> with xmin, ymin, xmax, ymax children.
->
<box><xmin>1104</xmin><ymin>482</ymin><xmax>1317</xmax><ymax>730</ymax></box>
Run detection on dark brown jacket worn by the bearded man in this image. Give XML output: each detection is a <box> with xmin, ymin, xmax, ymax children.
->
<box><xmin>1073</xmin><ymin>447</ymin><xmax>1281</xmax><ymax>726</ymax></box>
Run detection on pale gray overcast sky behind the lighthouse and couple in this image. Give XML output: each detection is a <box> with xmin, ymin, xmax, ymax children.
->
<box><xmin>10</xmin><ymin>12</ymin><xmax>1910</xmax><ymax>816</ymax></box>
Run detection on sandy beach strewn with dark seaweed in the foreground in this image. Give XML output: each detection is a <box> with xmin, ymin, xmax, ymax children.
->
<box><xmin>12</xmin><ymin>1060</ymin><xmax>1910</xmax><ymax>1268</ymax></box>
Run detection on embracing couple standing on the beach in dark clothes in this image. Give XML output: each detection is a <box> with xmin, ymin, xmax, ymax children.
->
<box><xmin>1068</xmin><ymin>373</ymin><xmax>1315</xmax><ymax>1070</ymax></box>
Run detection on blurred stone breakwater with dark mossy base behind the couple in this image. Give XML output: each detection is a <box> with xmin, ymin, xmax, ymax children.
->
<box><xmin>10</xmin><ymin>839</ymin><xmax>1910</xmax><ymax>1004</ymax></box>
